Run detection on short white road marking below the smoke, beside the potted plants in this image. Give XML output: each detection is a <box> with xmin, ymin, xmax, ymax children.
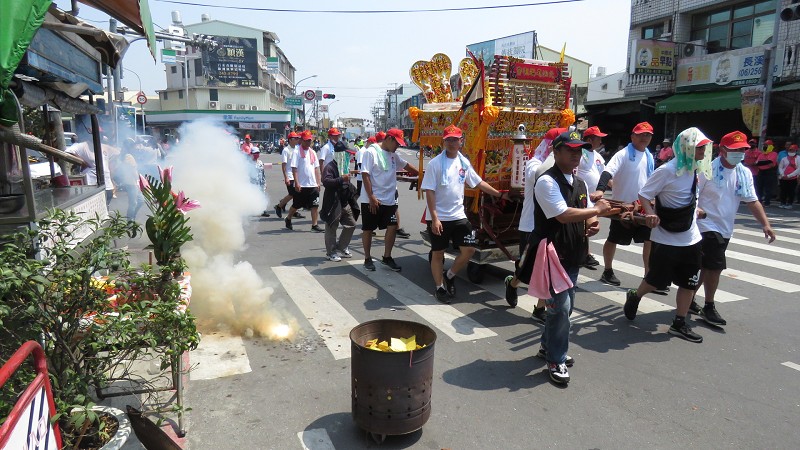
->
<box><xmin>189</xmin><ymin>332</ymin><xmax>252</xmax><ymax>380</ymax></box>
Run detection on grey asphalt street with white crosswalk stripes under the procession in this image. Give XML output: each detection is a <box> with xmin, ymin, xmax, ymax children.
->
<box><xmin>152</xmin><ymin>151</ymin><xmax>800</xmax><ymax>450</ymax></box>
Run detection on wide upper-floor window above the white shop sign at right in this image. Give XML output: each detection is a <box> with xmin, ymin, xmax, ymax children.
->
<box><xmin>690</xmin><ymin>0</ymin><xmax>776</xmax><ymax>53</ymax></box>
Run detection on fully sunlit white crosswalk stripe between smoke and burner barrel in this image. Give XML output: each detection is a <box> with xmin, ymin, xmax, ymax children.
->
<box><xmin>272</xmin><ymin>266</ymin><xmax>358</xmax><ymax>359</ymax></box>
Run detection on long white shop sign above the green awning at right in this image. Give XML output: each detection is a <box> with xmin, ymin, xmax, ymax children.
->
<box><xmin>675</xmin><ymin>45</ymin><xmax>783</xmax><ymax>92</ymax></box>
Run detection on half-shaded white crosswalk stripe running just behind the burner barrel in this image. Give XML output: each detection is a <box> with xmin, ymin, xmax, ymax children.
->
<box><xmin>349</xmin><ymin>260</ymin><xmax>497</xmax><ymax>342</ymax></box>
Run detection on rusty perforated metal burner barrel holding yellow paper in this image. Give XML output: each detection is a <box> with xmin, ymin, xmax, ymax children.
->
<box><xmin>350</xmin><ymin>320</ymin><xmax>436</xmax><ymax>435</ymax></box>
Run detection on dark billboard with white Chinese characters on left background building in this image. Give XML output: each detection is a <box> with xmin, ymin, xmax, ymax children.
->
<box><xmin>203</xmin><ymin>36</ymin><xmax>260</xmax><ymax>87</ymax></box>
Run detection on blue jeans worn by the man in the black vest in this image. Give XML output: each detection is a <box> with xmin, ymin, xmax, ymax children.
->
<box><xmin>542</xmin><ymin>267</ymin><xmax>580</xmax><ymax>364</ymax></box>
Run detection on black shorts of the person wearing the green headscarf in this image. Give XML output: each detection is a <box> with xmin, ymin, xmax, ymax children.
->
<box><xmin>644</xmin><ymin>242</ymin><xmax>702</xmax><ymax>291</ymax></box>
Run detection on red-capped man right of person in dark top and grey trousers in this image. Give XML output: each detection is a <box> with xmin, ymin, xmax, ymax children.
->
<box><xmin>358</xmin><ymin>128</ymin><xmax>419</xmax><ymax>272</ymax></box>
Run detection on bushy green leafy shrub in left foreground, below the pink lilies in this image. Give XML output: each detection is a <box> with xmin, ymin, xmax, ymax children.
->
<box><xmin>0</xmin><ymin>210</ymin><xmax>199</xmax><ymax>448</ymax></box>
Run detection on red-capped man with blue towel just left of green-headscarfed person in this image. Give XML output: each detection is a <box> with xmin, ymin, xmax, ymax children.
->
<box><xmin>591</xmin><ymin>122</ymin><xmax>666</xmax><ymax>288</ymax></box>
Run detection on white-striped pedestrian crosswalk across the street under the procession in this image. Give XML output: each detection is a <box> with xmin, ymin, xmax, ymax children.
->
<box><xmin>193</xmin><ymin>222</ymin><xmax>800</xmax><ymax>370</ymax></box>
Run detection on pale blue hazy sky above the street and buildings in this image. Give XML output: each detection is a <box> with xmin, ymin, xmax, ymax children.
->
<box><xmin>54</xmin><ymin>0</ymin><xmax>631</xmax><ymax>119</ymax></box>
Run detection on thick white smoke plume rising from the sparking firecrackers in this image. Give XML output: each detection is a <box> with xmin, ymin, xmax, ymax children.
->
<box><xmin>166</xmin><ymin>121</ymin><xmax>296</xmax><ymax>337</ymax></box>
